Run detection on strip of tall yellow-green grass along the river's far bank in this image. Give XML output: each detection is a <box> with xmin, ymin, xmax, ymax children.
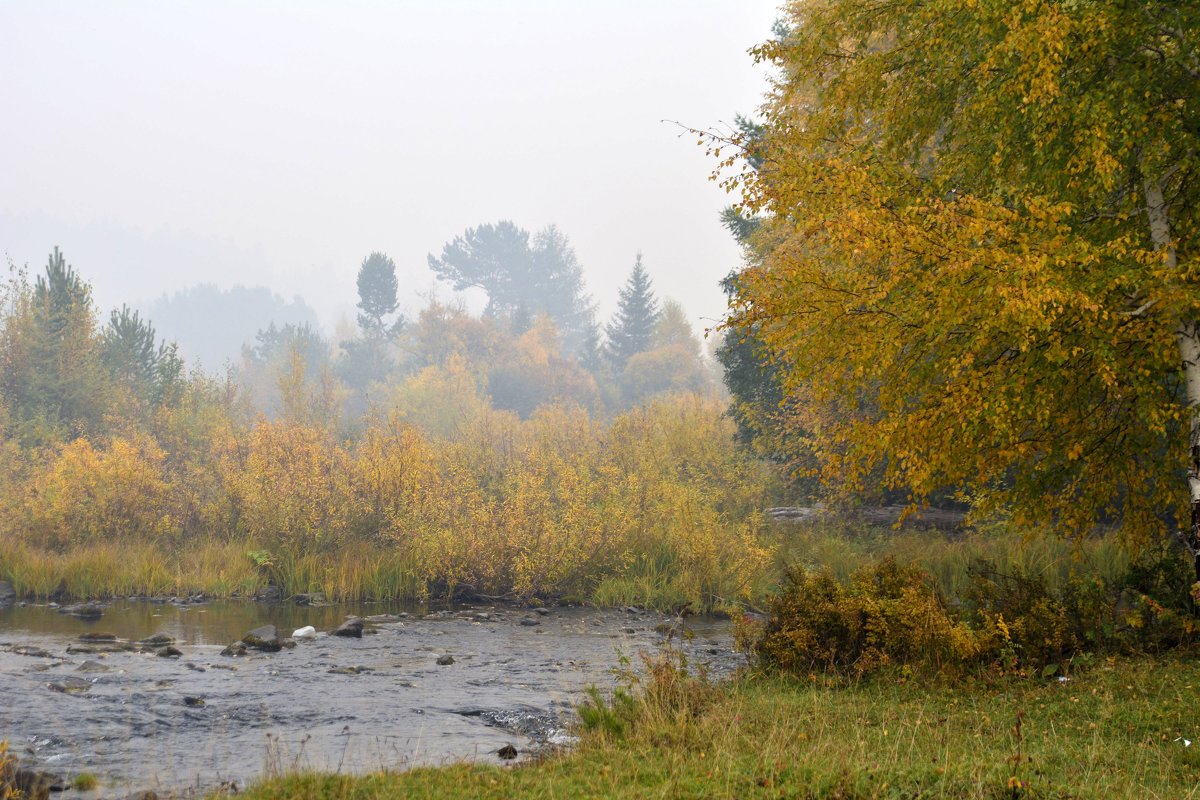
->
<box><xmin>0</xmin><ymin>535</ymin><xmax>776</xmax><ymax>610</ymax></box>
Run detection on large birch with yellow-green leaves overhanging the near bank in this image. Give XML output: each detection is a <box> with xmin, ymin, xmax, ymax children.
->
<box><xmin>712</xmin><ymin>0</ymin><xmax>1200</xmax><ymax>577</ymax></box>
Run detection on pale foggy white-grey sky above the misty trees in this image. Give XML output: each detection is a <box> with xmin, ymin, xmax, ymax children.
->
<box><xmin>0</xmin><ymin>0</ymin><xmax>779</xmax><ymax>338</ymax></box>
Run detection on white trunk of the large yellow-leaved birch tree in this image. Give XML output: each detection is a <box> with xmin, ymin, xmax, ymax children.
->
<box><xmin>1146</xmin><ymin>180</ymin><xmax>1200</xmax><ymax>582</ymax></box>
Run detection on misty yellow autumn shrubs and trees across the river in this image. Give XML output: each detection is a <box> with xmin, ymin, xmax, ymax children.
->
<box><xmin>0</xmin><ymin>234</ymin><xmax>778</xmax><ymax>607</ymax></box>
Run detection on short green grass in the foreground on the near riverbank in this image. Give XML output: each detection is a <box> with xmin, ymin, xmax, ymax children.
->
<box><xmin>231</xmin><ymin>657</ymin><xmax>1200</xmax><ymax>800</ymax></box>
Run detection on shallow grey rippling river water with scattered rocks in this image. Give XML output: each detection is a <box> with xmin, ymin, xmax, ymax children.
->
<box><xmin>0</xmin><ymin>601</ymin><xmax>740</xmax><ymax>798</ymax></box>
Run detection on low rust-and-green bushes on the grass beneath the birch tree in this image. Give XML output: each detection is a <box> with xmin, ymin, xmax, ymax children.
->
<box><xmin>743</xmin><ymin>543</ymin><xmax>1198</xmax><ymax>676</ymax></box>
